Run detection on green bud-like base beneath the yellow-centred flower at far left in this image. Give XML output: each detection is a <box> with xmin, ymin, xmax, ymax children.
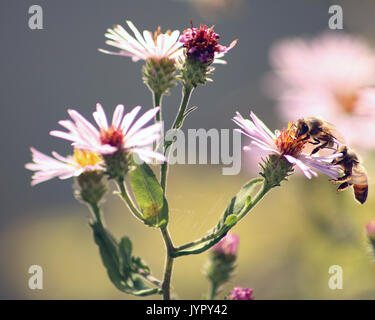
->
<box><xmin>75</xmin><ymin>170</ymin><xmax>107</xmax><ymax>204</ymax></box>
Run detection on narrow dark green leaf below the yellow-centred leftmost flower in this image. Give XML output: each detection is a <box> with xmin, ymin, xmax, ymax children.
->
<box><xmin>90</xmin><ymin>221</ymin><xmax>126</xmax><ymax>291</ymax></box>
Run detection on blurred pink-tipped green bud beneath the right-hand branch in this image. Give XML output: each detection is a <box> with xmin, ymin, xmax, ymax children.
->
<box><xmin>205</xmin><ymin>233</ymin><xmax>239</xmax><ymax>288</ymax></box>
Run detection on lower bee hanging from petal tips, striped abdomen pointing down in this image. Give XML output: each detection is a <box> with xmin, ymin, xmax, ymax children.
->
<box><xmin>332</xmin><ymin>146</ymin><xmax>368</xmax><ymax>204</ymax></box>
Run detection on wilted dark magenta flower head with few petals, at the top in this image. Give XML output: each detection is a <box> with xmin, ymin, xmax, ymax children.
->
<box><xmin>180</xmin><ymin>24</ymin><xmax>237</xmax><ymax>63</ymax></box>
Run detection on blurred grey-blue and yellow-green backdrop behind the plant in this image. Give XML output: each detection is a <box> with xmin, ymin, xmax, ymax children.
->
<box><xmin>0</xmin><ymin>0</ymin><xmax>375</xmax><ymax>299</ymax></box>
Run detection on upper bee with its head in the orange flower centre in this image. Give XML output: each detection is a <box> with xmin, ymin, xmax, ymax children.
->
<box><xmin>296</xmin><ymin>117</ymin><xmax>345</xmax><ymax>154</ymax></box>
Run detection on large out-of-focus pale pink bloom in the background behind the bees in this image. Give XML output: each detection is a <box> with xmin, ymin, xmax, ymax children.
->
<box><xmin>267</xmin><ymin>33</ymin><xmax>375</xmax><ymax>148</ymax></box>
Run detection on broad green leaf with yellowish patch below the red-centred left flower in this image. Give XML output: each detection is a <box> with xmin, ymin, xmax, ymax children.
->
<box><xmin>130</xmin><ymin>163</ymin><xmax>168</xmax><ymax>228</ymax></box>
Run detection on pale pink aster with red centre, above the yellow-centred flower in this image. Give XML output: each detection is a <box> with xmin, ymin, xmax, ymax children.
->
<box><xmin>50</xmin><ymin>103</ymin><xmax>165</xmax><ymax>162</ymax></box>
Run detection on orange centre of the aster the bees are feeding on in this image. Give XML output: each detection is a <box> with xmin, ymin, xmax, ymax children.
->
<box><xmin>275</xmin><ymin>121</ymin><xmax>307</xmax><ymax>156</ymax></box>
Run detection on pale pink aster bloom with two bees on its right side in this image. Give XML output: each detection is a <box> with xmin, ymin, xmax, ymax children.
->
<box><xmin>233</xmin><ymin>112</ymin><xmax>341</xmax><ymax>179</ymax></box>
